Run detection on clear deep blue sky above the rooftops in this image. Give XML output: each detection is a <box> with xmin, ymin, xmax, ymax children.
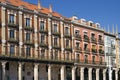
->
<box><xmin>24</xmin><ymin>0</ymin><xmax>120</xmax><ymax>32</ymax></box>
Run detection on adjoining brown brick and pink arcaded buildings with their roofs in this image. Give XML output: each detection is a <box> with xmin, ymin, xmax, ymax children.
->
<box><xmin>0</xmin><ymin>0</ymin><xmax>120</xmax><ymax>80</ymax></box>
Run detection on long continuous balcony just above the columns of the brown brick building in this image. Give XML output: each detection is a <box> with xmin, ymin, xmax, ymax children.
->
<box><xmin>0</xmin><ymin>51</ymin><xmax>74</xmax><ymax>65</ymax></box>
